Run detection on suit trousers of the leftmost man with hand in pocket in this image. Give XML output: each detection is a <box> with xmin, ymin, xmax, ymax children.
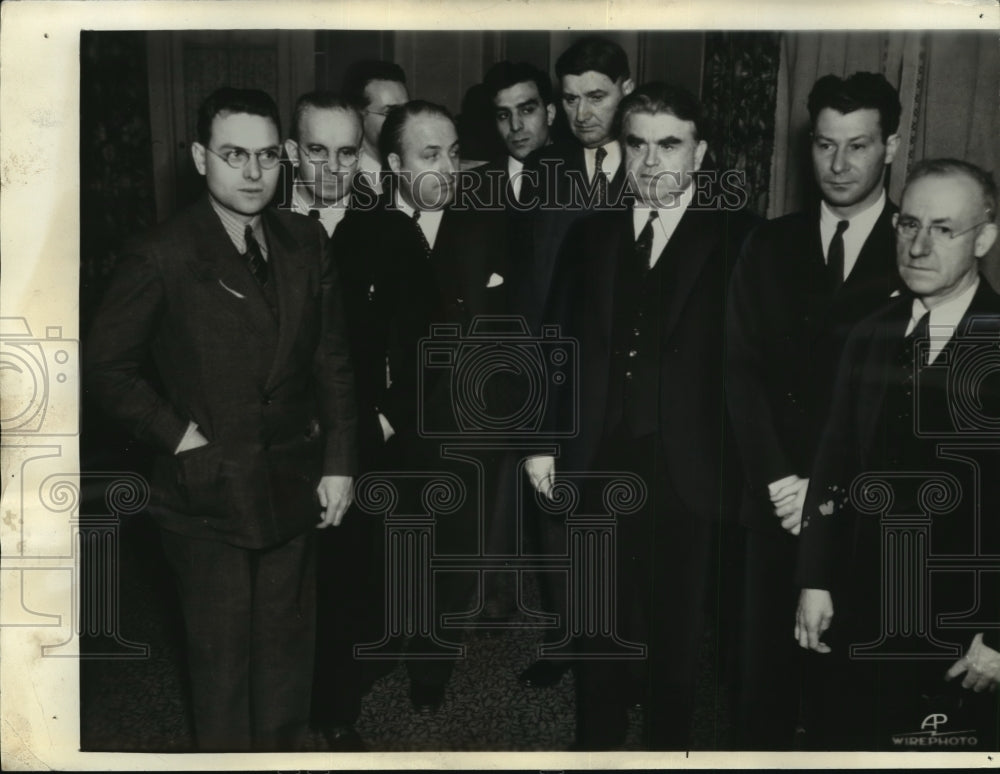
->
<box><xmin>161</xmin><ymin>530</ymin><xmax>316</xmax><ymax>752</ymax></box>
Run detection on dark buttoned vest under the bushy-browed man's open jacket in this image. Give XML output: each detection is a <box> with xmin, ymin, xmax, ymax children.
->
<box><xmin>604</xmin><ymin>239</ymin><xmax>666</xmax><ymax>438</ymax></box>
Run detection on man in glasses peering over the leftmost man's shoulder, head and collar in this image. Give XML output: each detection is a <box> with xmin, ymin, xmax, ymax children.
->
<box><xmin>285</xmin><ymin>91</ymin><xmax>362</xmax><ymax>236</ymax></box>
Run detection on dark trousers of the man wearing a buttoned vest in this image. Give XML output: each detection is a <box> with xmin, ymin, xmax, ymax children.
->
<box><xmin>576</xmin><ymin>430</ymin><xmax>713</xmax><ymax>750</ymax></box>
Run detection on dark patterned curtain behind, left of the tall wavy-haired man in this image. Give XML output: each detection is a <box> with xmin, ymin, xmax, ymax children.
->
<box><xmin>702</xmin><ymin>32</ymin><xmax>780</xmax><ymax>215</ymax></box>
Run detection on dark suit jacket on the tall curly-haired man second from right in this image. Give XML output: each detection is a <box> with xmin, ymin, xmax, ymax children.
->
<box><xmin>726</xmin><ymin>201</ymin><xmax>901</xmax><ymax>533</ymax></box>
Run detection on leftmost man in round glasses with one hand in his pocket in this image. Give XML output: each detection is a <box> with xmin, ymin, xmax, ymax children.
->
<box><xmin>85</xmin><ymin>88</ymin><xmax>356</xmax><ymax>750</ymax></box>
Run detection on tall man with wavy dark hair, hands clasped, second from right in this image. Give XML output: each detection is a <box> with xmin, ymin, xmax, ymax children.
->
<box><xmin>727</xmin><ymin>73</ymin><xmax>900</xmax><ymax>750</ymax></box>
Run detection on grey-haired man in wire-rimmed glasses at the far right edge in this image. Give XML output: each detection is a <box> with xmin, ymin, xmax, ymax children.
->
<box><xmin>795</xmin><ymin>159</ymin><xmax>1000</xmax><ymax>750</ymax></box>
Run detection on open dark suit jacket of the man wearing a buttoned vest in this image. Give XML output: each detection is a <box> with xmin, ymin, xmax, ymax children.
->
<box><xmin>546</xmin><ymin>209</ymin><xmax>754</xmax><ymax>517</ymax></box>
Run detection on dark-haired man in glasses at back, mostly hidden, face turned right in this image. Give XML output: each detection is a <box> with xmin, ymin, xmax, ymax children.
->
<box><xmin>342</xmin><ymin>59</ymin><xmax>410</xmax><ymax>194</ymax></box>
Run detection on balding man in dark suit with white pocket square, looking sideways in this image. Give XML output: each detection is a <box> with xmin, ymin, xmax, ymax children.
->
<box><xmin>333</xmin><ymin>100</ymin><xmax>506</xmax><ymax>712</ymax></box>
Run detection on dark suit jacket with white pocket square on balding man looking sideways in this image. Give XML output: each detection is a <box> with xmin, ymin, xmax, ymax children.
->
<box><xmin>333</xmin><ymin>199</ymin><xmax>507</xmax><ymax>448</ymax></box>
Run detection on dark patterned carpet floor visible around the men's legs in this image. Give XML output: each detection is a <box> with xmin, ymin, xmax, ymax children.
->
<box><xmin>80</xmin><ymin>518</ymin><xmax>732</xmax><ymax>752</ymax></box>
